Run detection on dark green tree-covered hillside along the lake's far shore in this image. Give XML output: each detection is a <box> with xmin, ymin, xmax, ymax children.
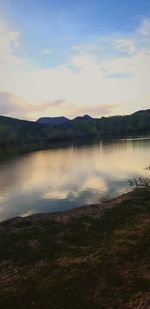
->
<box><xmin>0</xmin><ymin>110</ymin><xmax>150</xmax><ymax>147</ymax></box>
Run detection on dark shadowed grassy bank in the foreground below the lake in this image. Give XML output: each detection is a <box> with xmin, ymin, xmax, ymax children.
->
<box><xmin>0</xmin><ymin>191</ymin><xmax>150</xmax><ymax>309</ymax></box>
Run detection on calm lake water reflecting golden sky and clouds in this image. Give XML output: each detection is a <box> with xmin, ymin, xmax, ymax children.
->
<box><xmin>0</xmin><ymin>137</ymin><xmax>150</xmax><ymax>220</ymax></box>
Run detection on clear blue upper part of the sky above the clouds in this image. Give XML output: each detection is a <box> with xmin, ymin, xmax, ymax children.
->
<box><xmin>0</xmin><ymin>0</ymin><xmax>150</xmax><ymax>66</ymax></box>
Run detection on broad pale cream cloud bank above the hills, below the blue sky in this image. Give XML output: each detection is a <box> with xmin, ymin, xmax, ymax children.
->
<box><xmin>0</xmin><ymin>20</ymin><xmax>150</xmax><ymax>119</ymax></box>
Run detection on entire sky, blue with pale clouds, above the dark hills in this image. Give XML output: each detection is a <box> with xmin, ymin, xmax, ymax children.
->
<box><xmin>0</xmin><ymin>0</ymin><xmax>150</xmax><ymax>120</ymax></box>
